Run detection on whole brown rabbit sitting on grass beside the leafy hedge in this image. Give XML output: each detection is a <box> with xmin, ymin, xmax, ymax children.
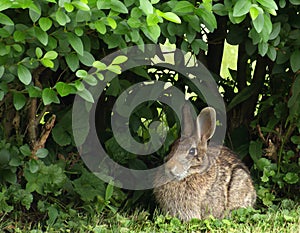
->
<box><xmin>154</xmin><ymin>105</ymin><xmax>256</xmax><ymax>221</ymax></box>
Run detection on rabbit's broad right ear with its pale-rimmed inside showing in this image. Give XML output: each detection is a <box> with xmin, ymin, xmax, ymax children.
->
<box><xmin>197</xmin><ymin>107</ymin><xmax>216</xmax><ymax>143</ymax></box>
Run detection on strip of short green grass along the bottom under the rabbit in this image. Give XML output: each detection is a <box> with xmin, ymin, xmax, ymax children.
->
<box><xmin>0</xmin><ymin>200</ymin><xmax>300</xmax><ymax>233</ymax></box>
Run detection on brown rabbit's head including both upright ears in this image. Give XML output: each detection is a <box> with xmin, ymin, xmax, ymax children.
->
<box><xmin>165</xmin><ymin>104</ymin><xmax>216</xmax><ymax>180</ymax></box>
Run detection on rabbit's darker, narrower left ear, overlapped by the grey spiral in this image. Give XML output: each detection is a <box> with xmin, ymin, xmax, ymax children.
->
<box><xmin>181</xmin><ymin>104</ymin><xmax>195</xmax><ymax>138</ymax></box>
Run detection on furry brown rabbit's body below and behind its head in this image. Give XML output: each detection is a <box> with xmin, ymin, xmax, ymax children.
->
<box><xmin>154</xmin><ymin>147</ymin><xmax>256</xmax><ymax>221</ymax></box>
